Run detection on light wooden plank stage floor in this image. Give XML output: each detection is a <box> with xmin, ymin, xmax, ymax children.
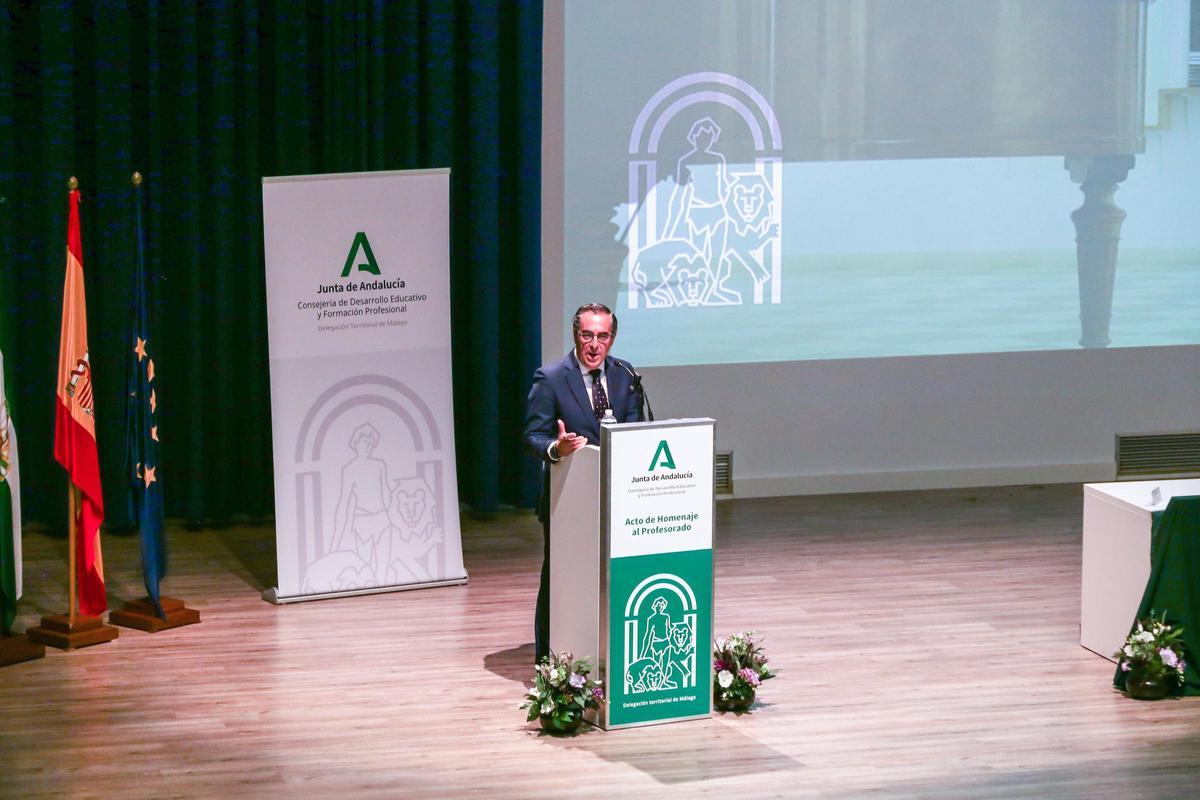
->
<box><xmin>0</xmin><ymin>485</ymin><xmax>1200</xmax><ymax>800</ymax></box>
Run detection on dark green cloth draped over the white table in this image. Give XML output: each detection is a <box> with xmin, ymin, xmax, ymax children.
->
<box><xmin>1113</xmin><ymin>494</ymin><xmax>1200</xmax><ymax>694</ymax></box>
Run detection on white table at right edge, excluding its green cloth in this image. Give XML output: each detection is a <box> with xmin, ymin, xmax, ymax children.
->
<box><xmin>1079</xmin><ymin>479</ymin><xmax>1200</xmax><ymax>661</ymax></box>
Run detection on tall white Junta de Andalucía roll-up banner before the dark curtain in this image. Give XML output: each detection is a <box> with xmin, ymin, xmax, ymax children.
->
<box><xmin>263</xmin><ymin>169</ymin><xmax>467</xmax><ymax>603</ymax></box>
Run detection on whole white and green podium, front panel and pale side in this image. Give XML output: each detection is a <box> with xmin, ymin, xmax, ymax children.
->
<box><xmin>550</xmin><ymin>419</ymin><xmax>715</xmax><ymax>728</ymax></box>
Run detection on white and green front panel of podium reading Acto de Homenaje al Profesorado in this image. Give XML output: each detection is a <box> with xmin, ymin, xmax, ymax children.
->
<box><xmin>600</xmin><ymin>419</ymin><xmax>714</xmax><ymax>728</ymax></box>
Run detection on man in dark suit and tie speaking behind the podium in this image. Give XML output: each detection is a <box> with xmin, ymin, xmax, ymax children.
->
<box><xmin>524</xmin><ymin>303</ymin><xmax>642</xmax><ymax>660</ymax></box>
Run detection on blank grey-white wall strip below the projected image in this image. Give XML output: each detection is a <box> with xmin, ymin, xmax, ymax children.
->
<box><xmin>638</xmin><ymin>341</ymin><xmax>1200</xmax><ymax>497</ymax></box>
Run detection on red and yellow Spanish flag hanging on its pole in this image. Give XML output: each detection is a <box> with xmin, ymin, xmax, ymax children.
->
<box><xmin>54</xmin><ymin>190</ymin><xmax>108</xmax><ymax>615</ymax></box>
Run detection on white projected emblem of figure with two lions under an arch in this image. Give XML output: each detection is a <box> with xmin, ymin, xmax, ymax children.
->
<box><xmin>613</xmin><ymin>73</ymin><xmax>782</xmax><ymax>308</ymax></box>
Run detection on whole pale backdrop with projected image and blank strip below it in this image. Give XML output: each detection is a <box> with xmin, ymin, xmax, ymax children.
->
<box><xmin>542</xmin><ymin>0</ymin><xmax>1200</xmax><ymax>493</ymax></box>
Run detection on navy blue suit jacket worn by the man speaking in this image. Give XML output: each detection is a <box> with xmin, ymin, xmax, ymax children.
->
<box><xmin>524</xmin><ymin>350</ymin><xmax>642</xmax><ymax>522</ymax></box>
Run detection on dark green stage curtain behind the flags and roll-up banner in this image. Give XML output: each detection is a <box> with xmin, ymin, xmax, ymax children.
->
<box><xmin>0</xmin><ymin>0</ymin><xmax>541</xmax><ymax>528</ymax></box>
